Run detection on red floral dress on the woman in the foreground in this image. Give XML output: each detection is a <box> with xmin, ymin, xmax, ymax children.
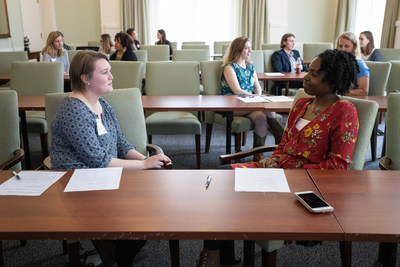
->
<box><xmin>232</xmin><ymin>98</ymin><xmax>358</xmax><ymax>170</ymax></box>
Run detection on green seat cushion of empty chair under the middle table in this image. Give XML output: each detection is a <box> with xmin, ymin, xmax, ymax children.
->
<box><xmin>146</xmin><ymin>111</ymin><xmax>201</xmax><ymax>135</ymax></box>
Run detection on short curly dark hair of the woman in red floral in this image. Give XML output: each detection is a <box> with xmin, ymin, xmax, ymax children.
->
<box><xmin>318</xmin><ymin>49</ymin><xmax>360</xmax><ymax>95</ymax></box>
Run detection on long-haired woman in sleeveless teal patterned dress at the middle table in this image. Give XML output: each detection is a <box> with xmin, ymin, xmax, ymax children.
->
<box><xmin>220</xmin><ymin>37</ymin><xmax>283</xmax><ymax>152</ymax></box>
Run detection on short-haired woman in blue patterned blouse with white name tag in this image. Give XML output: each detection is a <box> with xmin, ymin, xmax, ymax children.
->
<box><xmin>50</xmin><ymin>50</ymin><xmax>170</xmax><ymax>266</ymax></box>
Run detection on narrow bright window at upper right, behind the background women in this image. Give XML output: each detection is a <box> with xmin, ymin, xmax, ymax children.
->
<box><xmin>354</xmin><ymin>0</ymin><xmax>386</xmax><ymax>48</ymax></box>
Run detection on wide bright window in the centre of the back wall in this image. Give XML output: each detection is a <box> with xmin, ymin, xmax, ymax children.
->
<box><xmin>148</xmin><ymin>0</ymin><xmax>239</xmax><ymax>53</ymax></box>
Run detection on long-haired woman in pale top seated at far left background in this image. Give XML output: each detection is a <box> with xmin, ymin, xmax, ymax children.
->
<box><xmin>42</xmin><ymin>31</ymin><xmax>69</xmax><ymax>72</ymax></box>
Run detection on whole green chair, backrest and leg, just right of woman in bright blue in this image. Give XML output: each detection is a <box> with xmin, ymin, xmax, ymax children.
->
<box><xmin>365</xmin><ymin>61</ymin><xmax>391</xmax><ymax>161</ymax></box>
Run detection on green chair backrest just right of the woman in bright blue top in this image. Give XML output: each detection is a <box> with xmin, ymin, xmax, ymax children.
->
<box><xmin>365</xmin><ymin>61</ymin><xmax>392</xmax><ymax>96</ymax></box>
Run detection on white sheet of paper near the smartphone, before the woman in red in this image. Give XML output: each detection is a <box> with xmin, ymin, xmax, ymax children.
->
<box><xmin>235</xmin><ymin>168</ymin><xmax>290</xmax><ymax>193</ymax></box>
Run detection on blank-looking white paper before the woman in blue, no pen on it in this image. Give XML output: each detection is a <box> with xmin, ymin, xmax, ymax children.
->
<box><xmin>64</xmin><ymin>167</ymin><xmax>122</xmax><ymax>192</ymax></box>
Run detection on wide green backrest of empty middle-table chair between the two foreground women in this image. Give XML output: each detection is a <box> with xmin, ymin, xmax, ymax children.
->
<box><xmin>146</xmin><ymin>61</ymin><xmax>200</xmax><ymax>95</ymax></box>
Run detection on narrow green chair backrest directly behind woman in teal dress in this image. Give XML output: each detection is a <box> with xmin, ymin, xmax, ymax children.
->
<box><xmin>200</xmin><ymin>60</ymin><xmax>222</xmax><ymax>95</ymax></box>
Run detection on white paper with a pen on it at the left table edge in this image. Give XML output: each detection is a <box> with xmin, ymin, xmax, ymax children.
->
<box><xmin>0</xmin><ymin>171</ymin><xmax>65</xmax><ymax>196</ymax></box>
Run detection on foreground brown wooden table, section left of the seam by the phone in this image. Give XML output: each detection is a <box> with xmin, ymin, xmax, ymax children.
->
<box><xmin>0</xmin><ymin>170</ymin><xmax>344</xmax><ymax>264</ymax></box>
